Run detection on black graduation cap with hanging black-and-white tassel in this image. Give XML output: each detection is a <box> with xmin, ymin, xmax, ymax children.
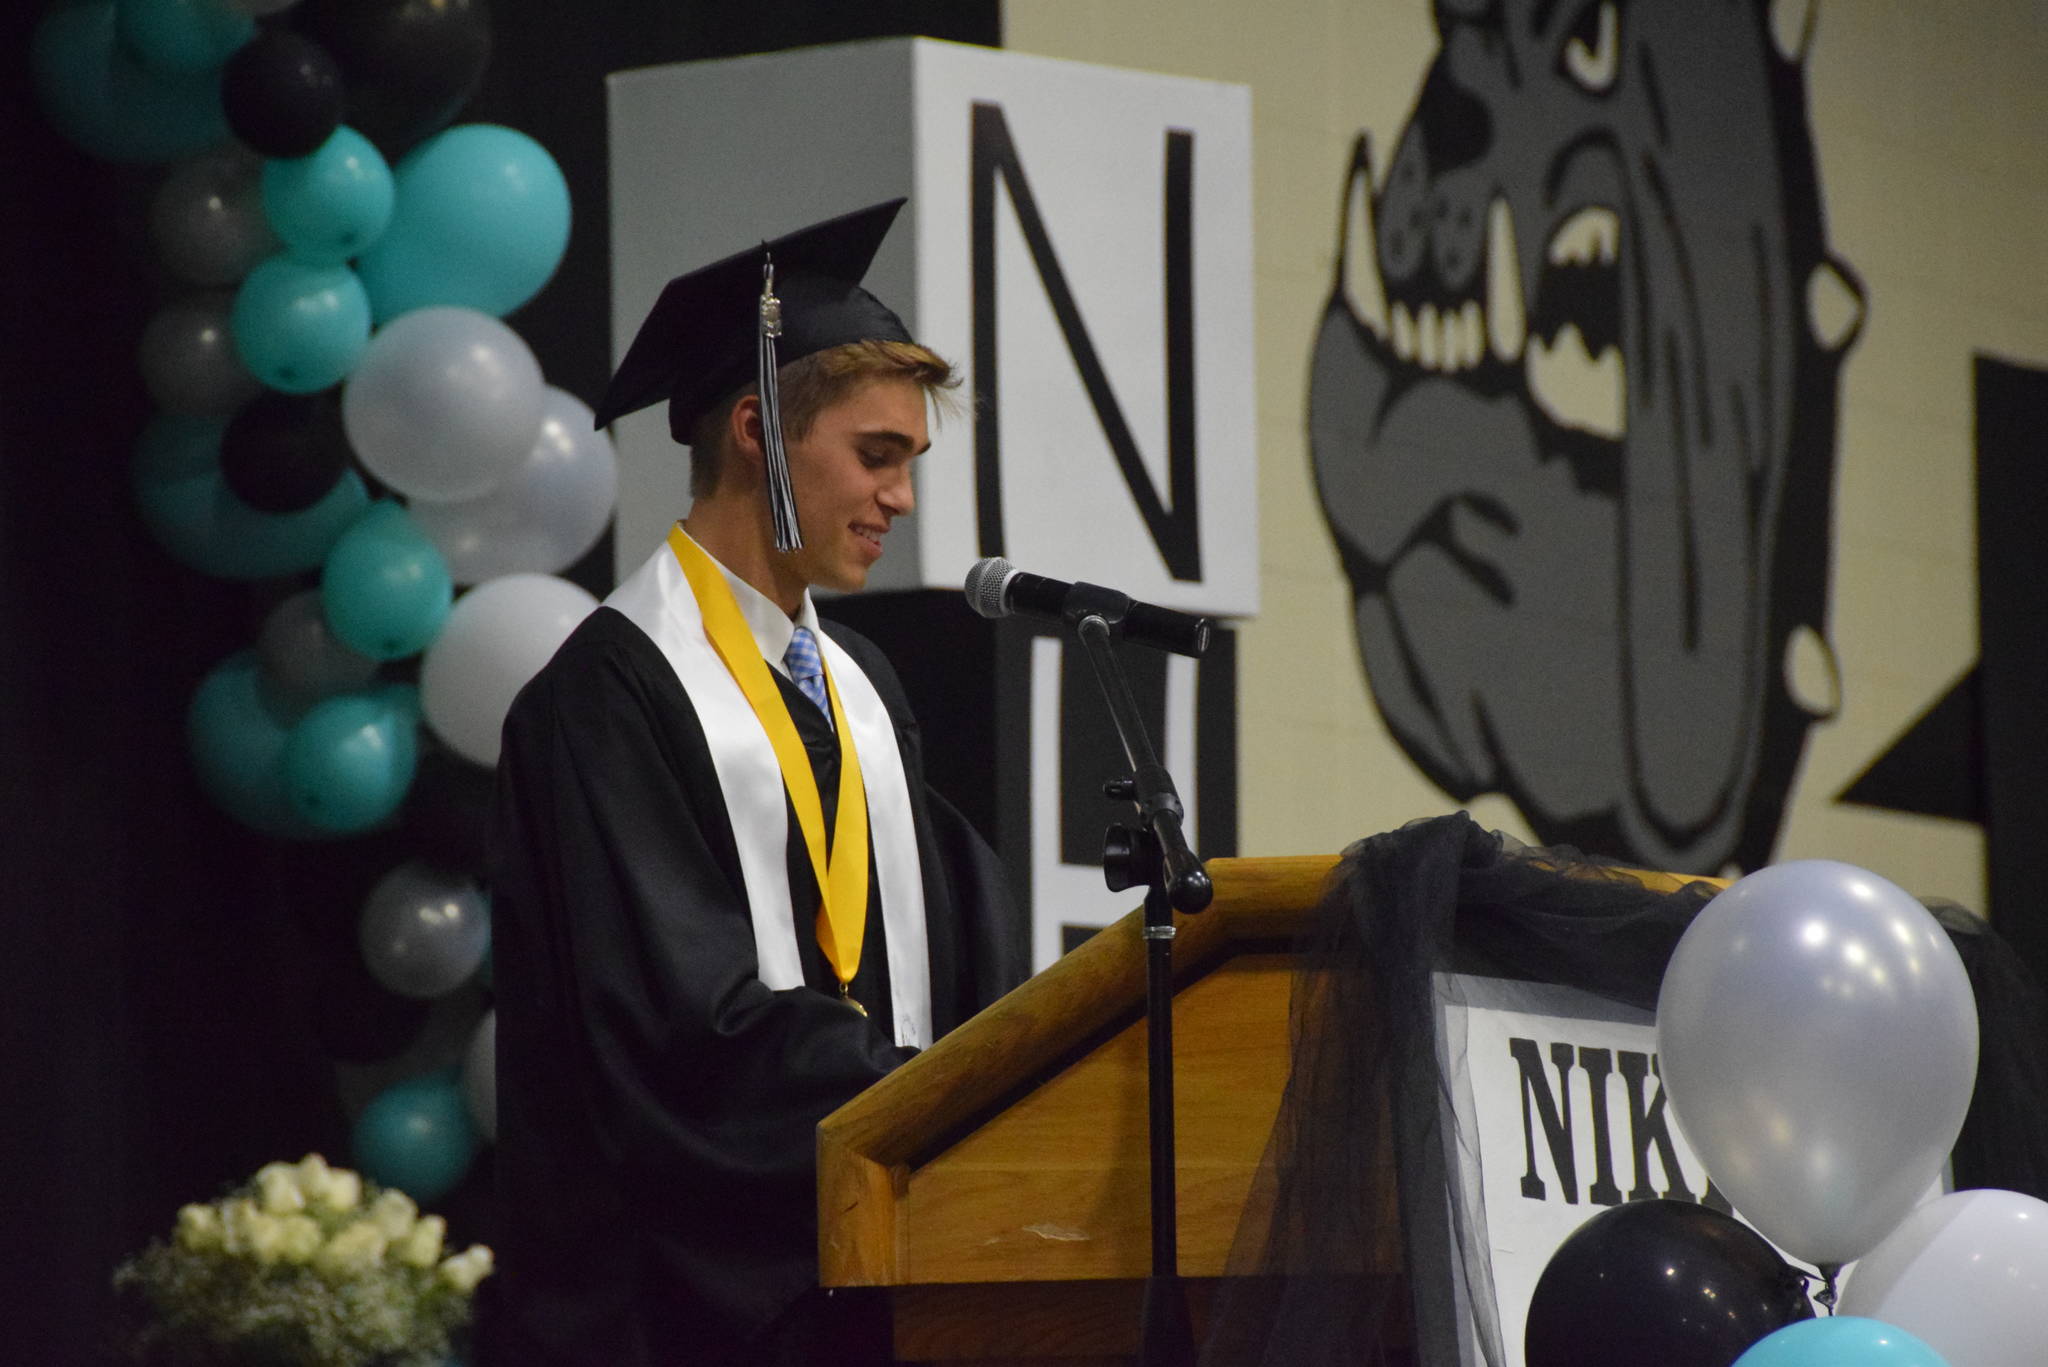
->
<box><xmin>596</xmin><ymin>199</ymin><xmax>911</xmax><ymax>551</ymax></box>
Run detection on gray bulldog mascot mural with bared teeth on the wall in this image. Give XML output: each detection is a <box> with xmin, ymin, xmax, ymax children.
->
<box><xmin>1309</xmin><ymin>0</ymin><xmax>1864</xmax><ymax>873</ymax></box>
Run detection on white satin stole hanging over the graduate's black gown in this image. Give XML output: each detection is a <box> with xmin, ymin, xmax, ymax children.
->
<box><xmin>604</xmin><ymin>543</ymin><xmax>932</xmax><ymax>1049</ymax></box>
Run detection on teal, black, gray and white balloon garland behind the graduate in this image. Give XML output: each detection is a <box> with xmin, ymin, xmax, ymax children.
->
<box><xmin>31</xmin><ymin>0</ymin><xmax>616</xmax><ymax>1201</ymax></box>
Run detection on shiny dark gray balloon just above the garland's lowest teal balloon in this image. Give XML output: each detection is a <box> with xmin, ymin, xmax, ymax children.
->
<box><xmin>356</xmin><ymin>859</ymin><xmax>492</xmax><ymax>998</ymax></box>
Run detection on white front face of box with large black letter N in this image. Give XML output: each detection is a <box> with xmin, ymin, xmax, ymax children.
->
<box><xmin>956</xmin><ymin>59</ymin><xmax>1257</xmax><ymax>615</ymax></box>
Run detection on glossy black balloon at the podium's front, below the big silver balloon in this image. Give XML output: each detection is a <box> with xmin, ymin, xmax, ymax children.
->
<box><xmin>1522</xmin><ymin>1201</ymin><xmax>1812</xmax><ymax>1367</ymax></box>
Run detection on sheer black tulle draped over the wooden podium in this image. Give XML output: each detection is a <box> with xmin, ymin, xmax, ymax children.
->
<box><xmin>1202</xmin><ymin>814</ymin><xmax>2048</xmax><ymax>1367</ymax></box>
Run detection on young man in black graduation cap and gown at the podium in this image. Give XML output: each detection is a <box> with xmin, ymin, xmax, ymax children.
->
<box><xmin>483</xmin><ymin>201</ymin><xmax>1026</xmax><ymax>1367</ymax></box>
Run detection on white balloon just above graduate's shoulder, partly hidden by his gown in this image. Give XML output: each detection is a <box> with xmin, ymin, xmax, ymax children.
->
<box><xmin>420</xmin><ymin>574</ymin><xmax>598</xmax><ymax>764</ymax></box>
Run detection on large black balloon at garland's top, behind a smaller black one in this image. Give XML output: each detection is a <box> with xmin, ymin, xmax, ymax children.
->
<box><xmin>289</xmin><ymin>0</ymin><xmax>492</xmax><ymax>156</ymax></box>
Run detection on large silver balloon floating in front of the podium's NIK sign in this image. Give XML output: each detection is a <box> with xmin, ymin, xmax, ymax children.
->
<box><xmin>1657</xmin><ymin>859</ymin><xmax>1976</xmax><ymax>1265</ymax></box>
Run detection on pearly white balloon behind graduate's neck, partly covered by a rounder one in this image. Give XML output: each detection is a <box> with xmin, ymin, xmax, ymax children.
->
<box><xmin>412</xmin><ymin>385</ymin><xmax>618</xmax><ymax>584</ymax></box>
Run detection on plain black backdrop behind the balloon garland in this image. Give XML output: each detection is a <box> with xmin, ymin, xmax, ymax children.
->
<box><xmin>0</xmin><ymin>0</ymin><xmax>1001</xmax><ymax>1365</ymax></box>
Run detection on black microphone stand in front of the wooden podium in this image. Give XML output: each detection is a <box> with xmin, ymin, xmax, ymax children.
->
<box><xmin>1065</xmin><ymin>584</ymin><xmax>1214</xmax><ymax>1367</ymax></box>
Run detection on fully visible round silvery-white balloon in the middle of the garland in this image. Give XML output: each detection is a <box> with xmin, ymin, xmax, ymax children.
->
<box><xmin>342</xmin><ymin>307</ymin><xmax>547</xmax><ymax>502</ymax></box>
